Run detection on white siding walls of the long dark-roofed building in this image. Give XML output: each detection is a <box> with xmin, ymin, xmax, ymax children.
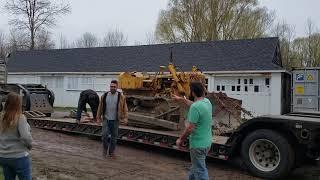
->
<box><xmin>8</xmin><ymin>73</ymin><xmax>281</xmax><ymax>116</ymax></box>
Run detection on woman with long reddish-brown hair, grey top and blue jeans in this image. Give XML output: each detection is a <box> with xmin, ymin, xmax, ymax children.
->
<box><xmin>0</xmin><ymin>93</ymin><xmax>32</xmax><ymax>180</ymax></box>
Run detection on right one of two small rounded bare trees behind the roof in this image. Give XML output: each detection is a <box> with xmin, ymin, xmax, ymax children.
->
<box><xmin>102</xmin><ymin>29</ymin><xmax>127</xmax><ymax>47</ymax></box>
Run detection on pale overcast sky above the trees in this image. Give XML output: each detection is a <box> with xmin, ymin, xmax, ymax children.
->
<box><xmin>0</xmin><ymin>0</ymin><xmax>320</xmax><ymax>45</ymax></box>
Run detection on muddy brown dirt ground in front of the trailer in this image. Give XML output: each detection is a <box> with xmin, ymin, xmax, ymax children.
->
<box><xmin>31</xmin><ymin>125</ymin><xmax>320</xmax><ymax>180</ymax></box>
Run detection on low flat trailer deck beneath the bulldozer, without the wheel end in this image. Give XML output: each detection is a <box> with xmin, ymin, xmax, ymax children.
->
<box><xmin>28</xmin><ymin>117</ymin><xmax>231</xmax><ymax>160</ymax></box>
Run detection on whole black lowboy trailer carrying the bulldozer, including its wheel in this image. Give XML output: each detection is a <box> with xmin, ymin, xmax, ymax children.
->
<box><xmin>28</xmin><ymin>112</ymin><xmax>320</xmax><ymax>179</ymax></box>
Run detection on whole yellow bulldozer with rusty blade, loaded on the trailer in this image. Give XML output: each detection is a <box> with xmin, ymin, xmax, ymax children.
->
<box><xmin>119</xmin><ymin>63</ymin><xmax>252</xmax><ymax>132</ymax></box>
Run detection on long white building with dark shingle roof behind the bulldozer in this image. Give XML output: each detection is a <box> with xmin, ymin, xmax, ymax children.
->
<box><xmin>8</xmin><ymin>38</ymin><xmax>290</xmax><ymax>115</ymax></box>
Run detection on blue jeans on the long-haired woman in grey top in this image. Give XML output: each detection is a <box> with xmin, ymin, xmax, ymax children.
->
<box><xmin>0</xmin><ymin>156</ymin><xmax>32</xmax><ymax>180</ymax></box>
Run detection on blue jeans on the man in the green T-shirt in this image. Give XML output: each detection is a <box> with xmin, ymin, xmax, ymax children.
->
<box><xmin>189</xmin><ymin>147</ymin><xmax>210</xmax><ymax>180</ymax></box>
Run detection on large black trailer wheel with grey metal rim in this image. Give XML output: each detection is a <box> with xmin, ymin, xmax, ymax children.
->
<box><xmin>241</xmin><ymin>129</ymin><xmax>295</xmax><ymax>179</ymax></box>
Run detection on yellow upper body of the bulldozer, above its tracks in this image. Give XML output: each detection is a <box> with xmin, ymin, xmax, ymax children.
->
<box><xmin>119</xmin><ymin>63</ymin><xmax>205</xmax><ymax>97</ymax></box>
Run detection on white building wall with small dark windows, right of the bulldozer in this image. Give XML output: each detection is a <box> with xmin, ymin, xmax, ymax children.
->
<box><xmin>209</xmin><ymin>73</ymin><xmax>281</xmax><ymax>116</ymax></box>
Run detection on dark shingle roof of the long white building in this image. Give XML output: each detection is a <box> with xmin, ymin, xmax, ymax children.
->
<box><xmin>8</xmin><ymin>38</ymin><xmax>283</xmax><ymax>72</ymax></box>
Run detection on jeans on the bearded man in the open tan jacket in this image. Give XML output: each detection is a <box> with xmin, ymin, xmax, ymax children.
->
<box><xmin>102</xmin><ymin>120</ymin><xmax>119</xmax><ymax>155</ymax></box>
